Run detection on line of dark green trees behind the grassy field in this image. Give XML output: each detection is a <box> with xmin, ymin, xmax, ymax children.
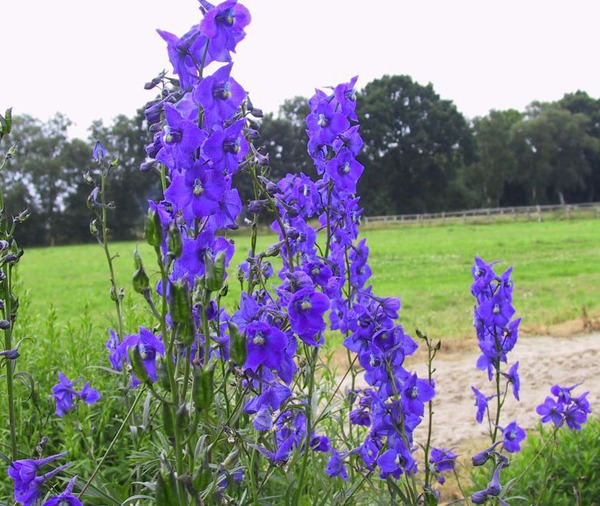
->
<box><xmin>0</xmin><ymin>75</ymin><xmax>600</xmax><ymax>245</ymax></box>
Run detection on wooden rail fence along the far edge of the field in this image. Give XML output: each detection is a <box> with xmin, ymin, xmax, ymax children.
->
<box><xmin>361</xmin><ymin>202</ymin><xmax>600</xmax><ymax>225</ymax></box>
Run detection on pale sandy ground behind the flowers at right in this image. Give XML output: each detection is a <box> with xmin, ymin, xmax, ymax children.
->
<box><xmin>340</xmin><ymin>332</ymin><xmax>600</xmax><ymax>448</ymax></box>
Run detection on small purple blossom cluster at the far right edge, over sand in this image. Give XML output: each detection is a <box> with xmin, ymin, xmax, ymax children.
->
<box><xmin>536</xmin><ymin>385</ymin><xmax>592</xmax><ymax>430</ymax></box>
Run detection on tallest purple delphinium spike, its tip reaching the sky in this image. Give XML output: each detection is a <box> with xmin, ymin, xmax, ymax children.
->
<box><xmin>107</xmin><ymin>0</ymin><xmax>255</xmax><ymax>386</ymax></box>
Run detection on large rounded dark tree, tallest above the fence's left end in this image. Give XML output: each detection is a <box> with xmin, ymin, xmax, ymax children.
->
<box><xmin>357</xmin><ymin>76</ymin><xmax>473</xmax><ymax>214</ymax></box>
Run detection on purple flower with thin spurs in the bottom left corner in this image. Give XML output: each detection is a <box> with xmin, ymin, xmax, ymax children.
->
<box><xmin>8</xmin><ymin>452</ymin><xmax>70</xmax><ymax>506</ymax></box>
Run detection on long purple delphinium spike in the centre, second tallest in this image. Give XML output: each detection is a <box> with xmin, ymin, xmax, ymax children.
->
<box><xmin>302</xmin><ymin>78</ymin><xmax>435</xmax><ymax>479</ymax></box>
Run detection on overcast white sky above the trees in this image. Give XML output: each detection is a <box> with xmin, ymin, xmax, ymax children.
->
<box><xmin>0</xmin><ymin>0</ymin><xmax>600</xmax><ymax>137</ymax></box>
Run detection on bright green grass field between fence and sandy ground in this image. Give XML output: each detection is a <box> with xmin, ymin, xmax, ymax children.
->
<box><xmin>14</xmin><ymin>219</ymin><xmax>600</xmax><ymax>339</ymax></box>
